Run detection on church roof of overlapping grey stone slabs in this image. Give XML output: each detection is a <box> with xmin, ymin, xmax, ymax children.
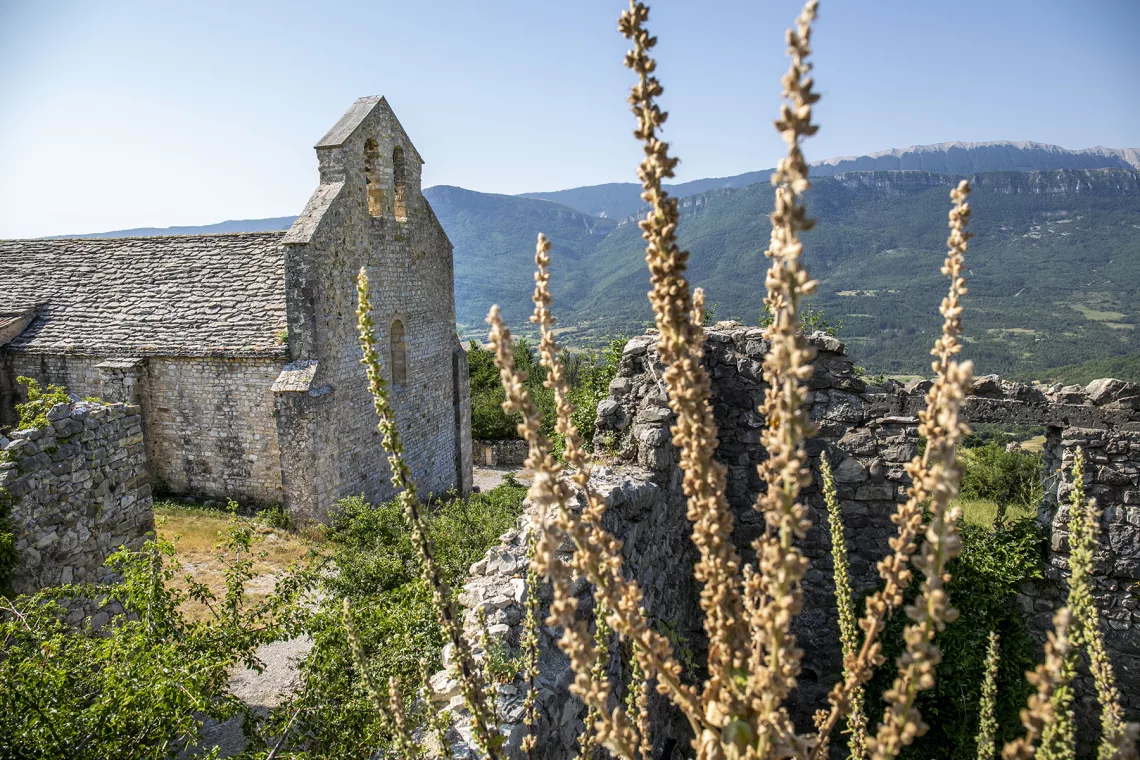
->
<box><xmin>0</xmin><ymin>232</ymin><xmax>286</xmax><ymax>357</ymax></box>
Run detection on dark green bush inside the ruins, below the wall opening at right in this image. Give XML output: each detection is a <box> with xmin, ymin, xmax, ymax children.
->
<box><xmin>857</xmin><ymin>520</ymin><xmax>1044</xmax><ymax>760</ymax></box>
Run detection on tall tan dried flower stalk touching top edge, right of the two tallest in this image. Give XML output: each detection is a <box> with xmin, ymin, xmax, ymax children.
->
<box><xmin>746</xmin><ymin>0</ymin><xmax>820</xmax><ymax>757</ymax></box>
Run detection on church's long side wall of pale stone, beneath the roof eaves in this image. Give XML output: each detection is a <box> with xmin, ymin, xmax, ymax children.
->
<box><xmin>3</xmin><ymin>354</ymin><xmax>285</xmax><ymax>505</ymax></box>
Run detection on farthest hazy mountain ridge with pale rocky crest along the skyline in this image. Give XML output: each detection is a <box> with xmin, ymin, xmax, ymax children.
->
<box><xmin>522</xmin><ymin>140</ymin><xmax>1140</xmax><ymax>219</ymax></box>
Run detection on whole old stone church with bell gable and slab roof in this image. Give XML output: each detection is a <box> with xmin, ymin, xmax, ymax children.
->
<box><xmin>0</xmin><ymin>97</ymin><xmax>471</xmax><ymax>520</ymax></box>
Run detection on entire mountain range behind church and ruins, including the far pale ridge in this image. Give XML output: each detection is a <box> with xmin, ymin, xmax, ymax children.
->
<box><xmin>40</xmin><ymin>142</ymin><xmax>1140</xmax><ymax>377</ymax></box>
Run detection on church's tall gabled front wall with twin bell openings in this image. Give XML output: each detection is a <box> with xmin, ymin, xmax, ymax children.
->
<box><xmin>277</xmin><ymin>100</ymin><xmax>471</xmax><ymax>520</ymax></box>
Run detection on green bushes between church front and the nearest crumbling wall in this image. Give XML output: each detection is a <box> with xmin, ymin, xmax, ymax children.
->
<box><xmin>271</xmin><ymin>480</ymin><xmax>526</xmax><ymax>759</ymax></box>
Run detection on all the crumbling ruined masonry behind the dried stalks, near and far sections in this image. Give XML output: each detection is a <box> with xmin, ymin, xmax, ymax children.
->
<box><xmin>432</xmin><ymin>322</ymin><xmax>1140</xmax><ymax>758</ymax></box>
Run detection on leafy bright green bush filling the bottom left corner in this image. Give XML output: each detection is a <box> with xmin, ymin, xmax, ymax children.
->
<box><xmin>0</xmin><ymin>525</ymin><xmax>308</xmax><ymax>760</ymax></box>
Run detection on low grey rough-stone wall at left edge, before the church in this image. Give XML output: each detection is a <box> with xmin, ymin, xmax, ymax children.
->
<box><xmin>0</xmin><ymin>402</ymin><xmax>154</xmax><ymax>594</ymax></box>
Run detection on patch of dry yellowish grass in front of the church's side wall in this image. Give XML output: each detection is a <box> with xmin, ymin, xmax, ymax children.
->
<box><xmin>154</xmin><ymin>501</ymin><xmax>320</xmax><ymax>620</ymax></box>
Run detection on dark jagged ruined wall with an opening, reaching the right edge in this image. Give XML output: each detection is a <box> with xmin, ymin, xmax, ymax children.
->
<box><xmin>596</xmin><ymin>322</ymin><xmax>1140</xmax><ymax>714</ymax></box>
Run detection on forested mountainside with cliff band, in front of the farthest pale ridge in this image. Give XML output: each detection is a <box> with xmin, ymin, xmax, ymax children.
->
<box><xmin>456</xmin><ymin>169</ymin><xmax>1140</xmax><ymax>376</ymax></box>
